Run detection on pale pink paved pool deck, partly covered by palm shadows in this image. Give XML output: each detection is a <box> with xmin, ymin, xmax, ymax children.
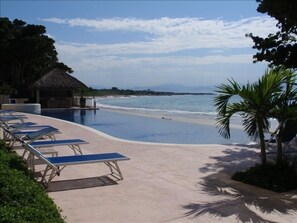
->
<box><xmin>12</xmin><ymin>114</ymin><xmax>297</xmax><ymax>223</ymax></box>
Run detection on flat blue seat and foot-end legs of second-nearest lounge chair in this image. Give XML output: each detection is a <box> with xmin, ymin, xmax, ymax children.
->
<box><xmin>30</xmin><ymin>139</ymin><xmax>88</xmax><ymax>155</ymax></box>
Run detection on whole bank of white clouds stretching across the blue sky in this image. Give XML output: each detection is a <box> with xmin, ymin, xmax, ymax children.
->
<box><xmin>44</xmin><ymin>16</ymin><xmax>276</xmax><ymax>88</ymax></box>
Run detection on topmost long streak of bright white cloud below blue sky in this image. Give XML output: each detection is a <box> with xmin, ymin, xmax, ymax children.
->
<box><xmin>43</xmin><ymin>16</ymin><xmax>276</xmax><ymax>36</ymax></box>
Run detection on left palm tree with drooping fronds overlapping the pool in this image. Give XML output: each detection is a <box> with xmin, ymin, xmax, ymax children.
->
<box><xmin>215</xmin><ymin>68</ymin><xmax>289</xmax><ymax>165</ymax></box>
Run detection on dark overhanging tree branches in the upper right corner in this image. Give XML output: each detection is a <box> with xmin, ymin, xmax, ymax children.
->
<box><xmin>247</xmin><ymin>0</ymin><xmax>297</xmax><ymax>68</ymax></box>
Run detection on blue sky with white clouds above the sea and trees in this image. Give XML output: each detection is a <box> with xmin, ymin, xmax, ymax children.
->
<box><xmin>0</xmin><ymin>0</ymin><xmax>277</xmax><ymax>91</ymax></box>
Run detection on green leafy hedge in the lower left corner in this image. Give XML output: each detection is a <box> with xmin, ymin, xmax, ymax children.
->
<box><xmin>0</xmin><ymin>141</ymin><xmax>64</xmax><ymax>223</ymax></box>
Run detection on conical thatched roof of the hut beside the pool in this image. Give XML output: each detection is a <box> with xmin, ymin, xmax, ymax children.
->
<box><xmin>30</xmin><ymin>68</ymin><xmax>87</xmax><ymax>89</ymax></box>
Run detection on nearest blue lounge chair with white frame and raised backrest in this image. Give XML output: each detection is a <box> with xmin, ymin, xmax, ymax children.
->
<box><xmin>21</xmin><ymin>140</ymin><xmax>130</xmax><ymax>187</ymax></box>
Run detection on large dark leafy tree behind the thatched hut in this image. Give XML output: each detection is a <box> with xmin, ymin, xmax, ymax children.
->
<box><xmin>0</xmin><ymin>18</ymin><xmax>72</xmax><ymax>94</ymax></box>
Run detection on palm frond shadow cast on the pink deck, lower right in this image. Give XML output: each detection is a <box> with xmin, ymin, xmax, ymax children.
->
<box><xmin>182</xmin><ymin>147</ymin><xmax>297</xmax><ymax>223</ymax></box>
